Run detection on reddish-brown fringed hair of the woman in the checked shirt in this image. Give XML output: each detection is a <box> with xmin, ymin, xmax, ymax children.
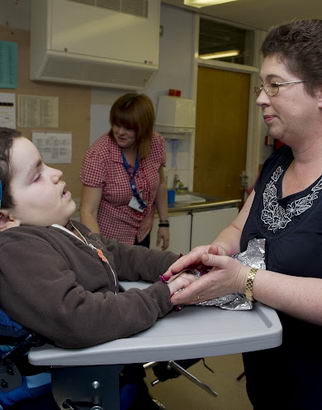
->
<box><xmin>110</xmin><ymin>93</ymin><xmax>155</xmax><ymax>158</ymax></box>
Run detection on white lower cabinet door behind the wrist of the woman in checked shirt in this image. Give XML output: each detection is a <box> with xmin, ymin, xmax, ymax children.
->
<box><xmin>150</xmin><ymin>213</ymin><xmax>191</xmax><ymax>254</ymax></box>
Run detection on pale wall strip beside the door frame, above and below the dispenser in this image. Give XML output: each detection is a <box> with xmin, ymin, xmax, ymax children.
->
<box><xmin>150</xmin><ymin>4</ymin><xmax>194</xmax><ymax>189</ymax></box>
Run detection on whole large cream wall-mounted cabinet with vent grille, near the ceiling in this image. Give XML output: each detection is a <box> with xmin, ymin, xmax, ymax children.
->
<box><xmin>31</xmin><ymin>0</ymin><xmax>160</xmax><ymax>89</ymax></box>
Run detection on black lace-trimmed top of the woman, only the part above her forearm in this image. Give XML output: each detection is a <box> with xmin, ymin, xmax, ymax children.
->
<box><xmin>241</xmin><ymin>147</ymin><xmax>322</xmax><ymax>278</ymax></box>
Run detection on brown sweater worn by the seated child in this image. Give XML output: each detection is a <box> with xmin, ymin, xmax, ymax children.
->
<box><xmin>0</xmin><ymin>223</ymin><xmax>178</xmax><ymax>348</ymax></box>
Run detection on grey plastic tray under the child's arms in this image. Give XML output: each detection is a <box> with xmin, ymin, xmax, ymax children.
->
<box><xmin>29</xmin><ymin>283</ymin><xmax>282</xmax><ymax>366</ymax></box>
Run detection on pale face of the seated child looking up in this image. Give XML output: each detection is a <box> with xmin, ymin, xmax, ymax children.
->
<box><xmin>9</xmin><ymin>137</ymin><xmax>76</xmax><ymax>226</ymax></box>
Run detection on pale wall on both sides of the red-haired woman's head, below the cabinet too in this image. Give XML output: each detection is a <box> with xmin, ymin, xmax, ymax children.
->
<box><xmin>91</xmin><ymin>4</ymin><xmax>194</xmax><ymax>188</ymax></box>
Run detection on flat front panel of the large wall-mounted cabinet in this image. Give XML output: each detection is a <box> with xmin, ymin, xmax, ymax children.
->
<box><xmin>49</xmin><ymin>0</ymin><xmax>160</xmax><ymax>65</ymax></box>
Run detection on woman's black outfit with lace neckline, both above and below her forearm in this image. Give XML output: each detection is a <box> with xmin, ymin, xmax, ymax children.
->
<box><xmin>241</xmin><ymin>147</ymin><xmax>322</xmax><ymax>410</ymax></box>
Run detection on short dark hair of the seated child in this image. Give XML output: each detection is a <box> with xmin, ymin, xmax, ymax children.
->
<box><xmin>0</xmin><ymin>127</ymin><xmax>22</xmax><ymax>209</ymax></box>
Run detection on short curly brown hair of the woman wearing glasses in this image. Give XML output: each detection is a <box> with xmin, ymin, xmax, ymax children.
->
<box><xmin>261</xmin><ymin>19</ymin><xmax>322</xmax><ymax>95</ymax></box>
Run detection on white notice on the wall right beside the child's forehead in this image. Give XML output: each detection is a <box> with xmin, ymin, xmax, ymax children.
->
<box><xmin>32</xmin><ymin>132</ymin><xmax>72</xmax><ymax>164</ymax></box>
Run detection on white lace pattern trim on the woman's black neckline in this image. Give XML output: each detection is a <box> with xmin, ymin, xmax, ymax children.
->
<box><xmin>261</xmin><ymin>166</ymin><xmax>322</xmax><ymax>233</ymax></box>
